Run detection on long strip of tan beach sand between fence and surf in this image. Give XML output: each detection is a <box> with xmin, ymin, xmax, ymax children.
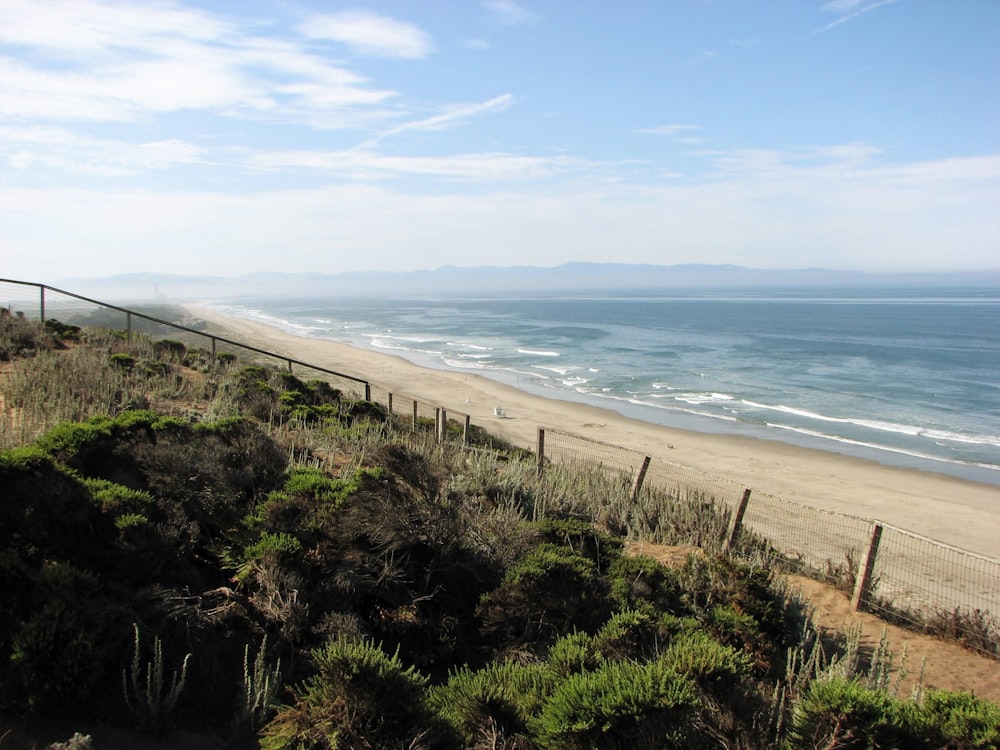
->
<box><xmin>185</xmin><ymin>305</ymin><xmax>1000</xmax><ymax>558</ymax></box>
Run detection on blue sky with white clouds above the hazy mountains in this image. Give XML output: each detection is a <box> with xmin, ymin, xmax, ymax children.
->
<box><xmin>0</xmin><ymin>0</ymin><xmax>1000</xmax><ymax>283</ymax></box>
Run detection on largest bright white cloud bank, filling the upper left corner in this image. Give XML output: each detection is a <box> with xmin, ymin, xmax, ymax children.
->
<box><xmin>0</xmin><ymin>0</ymin><xmax>402</xmax><ymax>128</ymax></box>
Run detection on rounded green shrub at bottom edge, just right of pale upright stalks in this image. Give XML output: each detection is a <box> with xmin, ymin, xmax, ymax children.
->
<box><xmin>260</xmin><ymin>639</ymin><xmax>434</xmax><ymax>750</ymax></box>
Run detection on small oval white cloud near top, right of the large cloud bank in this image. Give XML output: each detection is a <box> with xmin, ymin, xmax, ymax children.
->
<box><xmin>299</xmin><ymin>10</ymin><xmax>433</xmax><ymax>59</ymax></box>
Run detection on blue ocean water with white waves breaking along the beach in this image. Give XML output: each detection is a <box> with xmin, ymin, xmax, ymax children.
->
<box><xmin>213</xmin><ymin>288</ymin><xmax>1000</xmax><ymax>485</ymax></box>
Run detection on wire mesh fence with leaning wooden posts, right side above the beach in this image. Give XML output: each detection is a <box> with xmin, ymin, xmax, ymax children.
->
<box><xmin>539</xmin><ymin>429</ymin><xmax>1000</xmax><ymax>657</ymax></box>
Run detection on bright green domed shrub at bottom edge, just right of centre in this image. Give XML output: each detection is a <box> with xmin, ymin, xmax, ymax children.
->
<box><xmin>532</xmin><ymin>661</ymin><xmax>697</xmax><ymax>750</ymax></box>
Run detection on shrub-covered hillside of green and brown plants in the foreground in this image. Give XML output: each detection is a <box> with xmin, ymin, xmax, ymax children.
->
<box><xmin>0</xmin><ymin>315</ymin><xmax>1000</xmax><ymax>748</ymax></box>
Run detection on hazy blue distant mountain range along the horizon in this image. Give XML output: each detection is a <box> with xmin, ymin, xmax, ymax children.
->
<box><xmin>51</xmin><ymin>263</ymin><xmax>1000</xmax><ymax>301</ymax></box>
